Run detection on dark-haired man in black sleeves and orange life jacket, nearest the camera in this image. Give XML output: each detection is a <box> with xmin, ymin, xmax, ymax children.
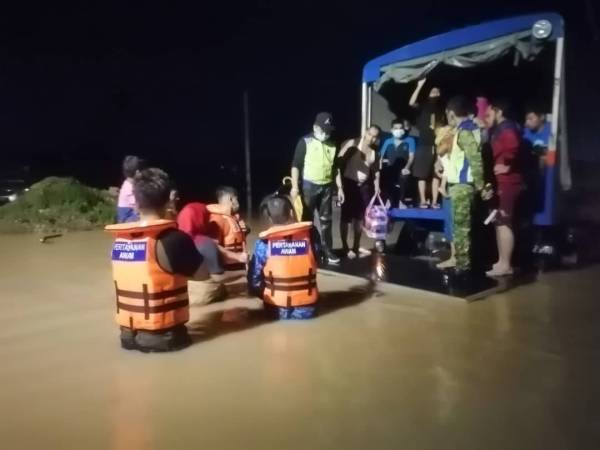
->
<box><xmin>106</xmin><ymin>168</ymin><xmax>208</xmax><ymax>352</ymax></box>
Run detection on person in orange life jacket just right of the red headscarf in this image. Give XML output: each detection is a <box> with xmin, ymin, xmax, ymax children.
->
<box><xmin>207</xmin><ymin>186</ymin><xmax>250</xmax><ymax>270</ymax></box>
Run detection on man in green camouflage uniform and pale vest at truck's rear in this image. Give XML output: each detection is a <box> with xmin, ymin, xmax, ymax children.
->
<box><xmin>438</xmin><ymin>96</ymin><xmax>492</xmax><ymax>272</ymax></box>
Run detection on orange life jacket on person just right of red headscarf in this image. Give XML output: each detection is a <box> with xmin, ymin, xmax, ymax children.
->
<box><xmin>206</xmin><ymin>204</ymin><xmax>246</xmax><ymax>270</ymax></box>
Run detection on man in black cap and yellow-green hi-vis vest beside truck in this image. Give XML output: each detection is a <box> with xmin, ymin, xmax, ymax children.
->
<box><xmin>290</xmin><ymin>112</ymin><xmax>344</xmax><ymax>264</ymax></box>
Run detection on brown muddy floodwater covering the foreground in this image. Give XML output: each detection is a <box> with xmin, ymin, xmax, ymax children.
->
<box><xmin>0</xmin><ymin>232</ymin><xmax>600</xmax><ymax>450</ymax></box>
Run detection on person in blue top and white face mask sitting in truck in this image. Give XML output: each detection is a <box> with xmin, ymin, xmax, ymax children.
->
<box><xmin>380</xmin><ymin>119</ymin><xmax>416</xmax><ymax>209</ymax></box>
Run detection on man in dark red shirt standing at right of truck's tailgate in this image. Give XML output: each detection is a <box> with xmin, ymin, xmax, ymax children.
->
<box><xmin>487</xmin><ymin>100</ymin><xmax>523</xmax><ymax>277</ymax></box>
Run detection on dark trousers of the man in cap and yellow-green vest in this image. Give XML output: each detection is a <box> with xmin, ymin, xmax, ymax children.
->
<box><xmin>302</xmin><ymin>180</ymin><xmax>333</xmax><ymax>251</ymax></box>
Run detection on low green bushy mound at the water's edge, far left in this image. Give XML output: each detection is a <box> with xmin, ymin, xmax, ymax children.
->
<box><xmin>0</xmin><ymin>177</ymin><xmax>115</xmax><ymax>233</ymax></box>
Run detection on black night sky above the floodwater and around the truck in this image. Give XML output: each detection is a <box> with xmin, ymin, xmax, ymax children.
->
<box><xmin>0</xmin><ymin>0</ymin><xmax>600</xmax><ymax>204</ymax></box>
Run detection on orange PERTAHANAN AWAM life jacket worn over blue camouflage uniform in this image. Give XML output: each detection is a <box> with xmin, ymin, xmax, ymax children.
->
<box><xmin>259</xmin><ymin>222</ymin><xmax>319</xmax><ymax>308</ymax></box>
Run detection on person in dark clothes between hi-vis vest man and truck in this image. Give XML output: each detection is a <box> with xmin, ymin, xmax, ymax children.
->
<box><xmin>338</xmin><ymin>125</ymin><xmax>381</xmax><ymax>259</ymax></box>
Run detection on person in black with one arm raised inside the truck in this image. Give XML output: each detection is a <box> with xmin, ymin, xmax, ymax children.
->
<box><xmin>409</xmin><ymin>78</ymin><xmax>444</xmax><ymax>208</ymax></box>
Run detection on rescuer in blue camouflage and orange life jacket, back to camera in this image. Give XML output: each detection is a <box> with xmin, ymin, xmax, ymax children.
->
<box><xmin>248</xmin><ymin>195</ymin><xmax>321</xmax><ymax>320</ymax></box>
